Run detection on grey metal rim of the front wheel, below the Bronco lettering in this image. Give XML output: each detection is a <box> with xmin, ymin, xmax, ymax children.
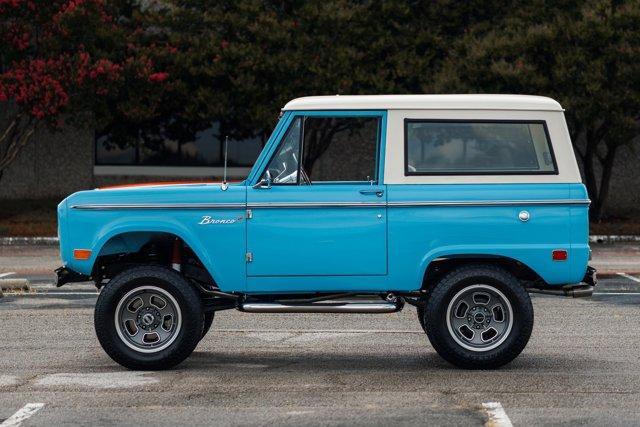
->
<box><xmin>115</xmin><ymin>286</ymin><xmax>182</xmax><ymax>353</ymax></box>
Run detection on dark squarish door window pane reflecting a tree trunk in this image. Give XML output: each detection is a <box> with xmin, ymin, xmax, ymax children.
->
<box><xmin>301</xmin><ymin>116</ymin><xmax>380</xmax><ymax>183</ymax></box>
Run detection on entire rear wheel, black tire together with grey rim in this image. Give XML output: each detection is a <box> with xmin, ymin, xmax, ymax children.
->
<box><xmin>424</xmin><ymin>265</ymin><xmax>533</xmax><ymax>369</ymax></box>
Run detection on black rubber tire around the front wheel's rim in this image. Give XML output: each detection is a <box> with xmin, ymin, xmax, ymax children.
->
<box><xmin>94</xmin><ymin>266</ymin><xmax>204</xmax><ymax>370</ymax></box>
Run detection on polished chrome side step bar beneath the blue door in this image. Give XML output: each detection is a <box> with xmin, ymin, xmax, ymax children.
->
<box><xmin>238</xmin><ymin>298</ymin><xmax>404</xmax><ymax>314</ymax></box>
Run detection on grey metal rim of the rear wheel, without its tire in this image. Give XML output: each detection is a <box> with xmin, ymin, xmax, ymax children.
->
<box><xmin>446</xmin><ymin>284</ymin><xmax>513</xmax><ymax>352</ymax></box>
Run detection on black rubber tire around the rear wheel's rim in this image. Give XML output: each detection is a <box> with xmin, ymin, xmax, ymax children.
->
<box><xmin>424</xmin><ymin>265</ymin><xmax>533</xmax><ymax>369</ymax></box>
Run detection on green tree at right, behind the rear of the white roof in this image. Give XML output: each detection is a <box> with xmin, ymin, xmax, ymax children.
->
<box><xmin>436</xmin><ymin>0</ymin><xmax>640</xmax><ymax>220</ymax></box>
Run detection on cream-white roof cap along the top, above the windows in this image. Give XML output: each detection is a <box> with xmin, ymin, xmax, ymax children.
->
<box><xmin>283</xmin><ymin>94</ymin><xmax>563</xmax><ymax>111</ymax></box>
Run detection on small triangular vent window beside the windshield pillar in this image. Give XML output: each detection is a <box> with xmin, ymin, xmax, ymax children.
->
<box><xmin>262</xmin><ymin>117</ymin><xmax>302</xmax><ymax>184</ymax></box>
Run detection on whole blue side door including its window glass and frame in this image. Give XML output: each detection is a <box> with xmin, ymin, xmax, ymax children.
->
<box><xmin>247</xmin><ymin>112</ymin><xmax>387</xmax><ymax>282</ymax></box>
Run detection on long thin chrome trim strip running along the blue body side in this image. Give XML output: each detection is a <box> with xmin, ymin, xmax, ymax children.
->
<box><xmin>71</xmin><ymin>199</ymin><xmax>591</xmax><ymax>210</ymax></box>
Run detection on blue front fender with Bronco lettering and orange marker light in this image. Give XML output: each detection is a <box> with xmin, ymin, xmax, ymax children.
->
<box><xmin>60</xmin><ymin>184</ymin><xmax>246</xmax><ymax>291</ymax></box>
